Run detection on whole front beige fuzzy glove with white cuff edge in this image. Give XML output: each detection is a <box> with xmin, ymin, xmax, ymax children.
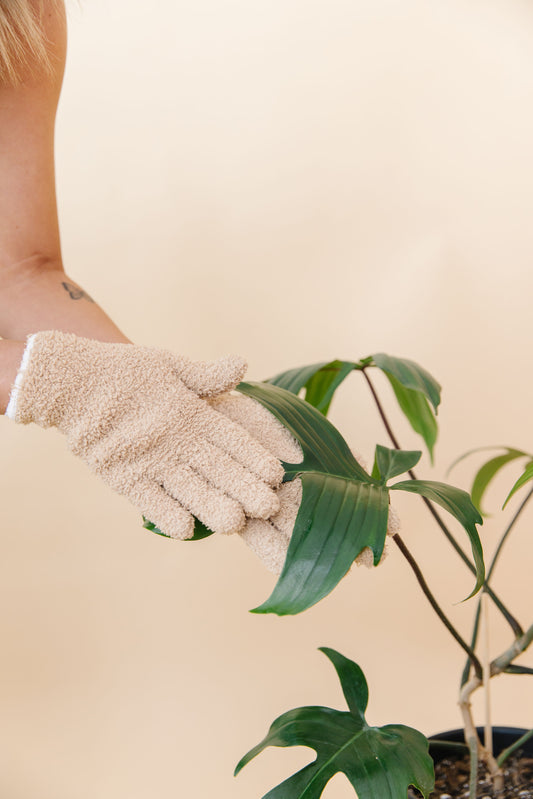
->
<box><xmin>6</xmin><ymin>331</ymin><xmax>283</xmax><ymax>538</ymax></box>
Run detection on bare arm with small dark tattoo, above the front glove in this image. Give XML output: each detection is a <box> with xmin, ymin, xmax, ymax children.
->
<box><xmin>0</xmin><ymin>0</ymin><xmax>128</xmax><ymax>412</ymax></box>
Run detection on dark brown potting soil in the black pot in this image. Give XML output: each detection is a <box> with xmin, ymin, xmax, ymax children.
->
<box><xmin>408</xmin><ymin>754</ymin><xmax>533</xmax><ymax>799</ymax></box>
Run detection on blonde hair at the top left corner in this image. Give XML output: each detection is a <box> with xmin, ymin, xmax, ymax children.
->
<box><xmin>0</xmin><ymin>0</ymin><xmax>55</xmax><ymax>85</ymax></box>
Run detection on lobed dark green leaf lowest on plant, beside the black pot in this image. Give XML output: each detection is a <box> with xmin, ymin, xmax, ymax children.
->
<box><xmin>235</xmin><ymin>648</ymin><xmax>435</xmax><ymax>799</ymax></box>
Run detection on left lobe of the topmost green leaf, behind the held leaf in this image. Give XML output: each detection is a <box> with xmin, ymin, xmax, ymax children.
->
<box><xmin>267</xmin><ymin>360</ymin><xmax>358</xmax><ymax>416</ymax></box>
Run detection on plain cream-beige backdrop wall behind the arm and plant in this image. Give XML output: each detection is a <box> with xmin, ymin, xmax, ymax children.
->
<box><xmin>0</xmin><ymin>0</ymin><xmax>533</xmax><ymax>799</ymax></box>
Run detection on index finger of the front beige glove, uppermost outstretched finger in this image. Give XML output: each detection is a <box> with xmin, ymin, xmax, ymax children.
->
<box><xmin>196</xmin><ymin>403</ymin><xmax>284</xmax><ymax>486</ymax></box>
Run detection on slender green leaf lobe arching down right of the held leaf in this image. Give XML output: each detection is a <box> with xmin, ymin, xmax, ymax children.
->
<box><xmin>390</xmin><ymin>480</ymin><xmax>485</xmax><ymax>599</ymax></box>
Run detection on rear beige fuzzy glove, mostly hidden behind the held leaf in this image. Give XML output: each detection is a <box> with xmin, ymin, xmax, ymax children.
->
<box><xmin>210</xmin><ymin>394</ymin><xmax>399</xmax><ymax>575</ymax></box>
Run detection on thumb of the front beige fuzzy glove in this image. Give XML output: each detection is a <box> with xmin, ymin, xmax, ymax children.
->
<box><xmin>174</xmin><ymin>355</ymin><xmax>247</xmax><ymax>397</ymax></box>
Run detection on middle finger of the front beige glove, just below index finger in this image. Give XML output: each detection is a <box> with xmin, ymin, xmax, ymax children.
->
<box><xmin>179</xmin><ymin>440</ymin><xmax>280</xmax><ymax>519</ymax></box>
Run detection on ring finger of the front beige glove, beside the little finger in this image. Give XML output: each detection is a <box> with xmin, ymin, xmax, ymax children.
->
<box><xmin>156</xmin><ymin>463</ymin><xmax>245</xmax><ymax>534</ymax></box>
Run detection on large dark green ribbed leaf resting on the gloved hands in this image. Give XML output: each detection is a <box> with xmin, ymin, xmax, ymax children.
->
<box><xmin>238</xmin><ymin>383</ymin><xmax>389</xmax><ymax>616</ymax></box>
